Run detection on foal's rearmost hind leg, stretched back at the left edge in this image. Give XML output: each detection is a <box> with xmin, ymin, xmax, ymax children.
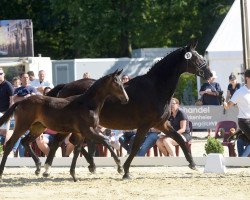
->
<box><xmin>0</xmin><ymin>129</ymin><xmax>25</xmax><ymax>179</ymax></box>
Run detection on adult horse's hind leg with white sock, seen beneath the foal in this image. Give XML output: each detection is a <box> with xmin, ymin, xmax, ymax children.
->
<box><xmin>43</xmin><ymin>133</ymin><xmax>69</xmax><ymax>177</ymax></box>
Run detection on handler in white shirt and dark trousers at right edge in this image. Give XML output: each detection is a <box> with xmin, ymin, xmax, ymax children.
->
<box><xmin>224</xmin><ymin>69</ymin><xmax>250</xmax><ymax>155</ymax></box>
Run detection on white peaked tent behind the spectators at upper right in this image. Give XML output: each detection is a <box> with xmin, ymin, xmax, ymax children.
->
<box><xmin>205</xmin><ymin>0</ymin><xmax>250</xmax><ymax>94</ymax></box>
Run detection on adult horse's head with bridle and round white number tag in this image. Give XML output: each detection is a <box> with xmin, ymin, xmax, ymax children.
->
<box><xmin>182</xmin><ymin>42</ymin><xmax>212</xmax><ymax>80</ymax></box>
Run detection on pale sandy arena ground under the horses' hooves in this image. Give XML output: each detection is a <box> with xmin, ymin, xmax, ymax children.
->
<box><xmin>0</xmin><ymin>130</ymin><xmax>250</xmax><ymax>200</ymax></box>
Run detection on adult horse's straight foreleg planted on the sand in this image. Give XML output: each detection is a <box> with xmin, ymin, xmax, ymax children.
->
<box><xmin>123</xmin><ymin>128</ymin><xmax>149</xmax><ymax>179</ymax></box>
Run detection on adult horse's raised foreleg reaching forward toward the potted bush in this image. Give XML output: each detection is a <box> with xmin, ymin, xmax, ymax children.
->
<box><xmin>167</xmin><ymin>131</ymin><xmax>196</xmax><ymax>170</ymax></box>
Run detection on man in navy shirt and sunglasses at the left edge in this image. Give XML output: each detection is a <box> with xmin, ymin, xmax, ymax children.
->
<box><xmin>0</xmin><ymin>68</ymin><xmax>13</xmax><ymax>152</ymax></box>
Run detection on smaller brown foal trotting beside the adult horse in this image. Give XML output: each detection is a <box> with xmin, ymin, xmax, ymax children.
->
<box><xmin>0</xmin><ymin>70</ymin><xmax>129</xmax><ymax>180</ymax></box>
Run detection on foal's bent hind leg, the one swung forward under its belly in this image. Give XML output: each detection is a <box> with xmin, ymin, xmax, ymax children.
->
<box><xmin>21</xmin><ymin>134</ymin><xmax>41</xmax><ymax>175</ymax></box>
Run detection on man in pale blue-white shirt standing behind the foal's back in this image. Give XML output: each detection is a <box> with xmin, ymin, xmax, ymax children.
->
<box><xmin>31</xmin><ymin>70</ymin><xmax>54</xmax><ymax>94</ymax></box>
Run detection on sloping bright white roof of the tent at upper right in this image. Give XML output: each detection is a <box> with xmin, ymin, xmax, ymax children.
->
<box><xmin>206</xmin><ymin>0</ymin><xmax>250</xmax><ymax>52</ymax></box>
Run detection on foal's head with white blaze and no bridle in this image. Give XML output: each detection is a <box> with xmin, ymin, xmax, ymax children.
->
<box><xmin>109</xmin><ymin>69</ymin><xmax>129</xmax><ymax>104</ymax></box>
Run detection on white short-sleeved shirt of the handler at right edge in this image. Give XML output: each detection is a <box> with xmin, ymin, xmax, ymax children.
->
<box><xmin>230</xmin><ymin>85</ymin><xmax>250</xmax><ymax>119</ymax></box>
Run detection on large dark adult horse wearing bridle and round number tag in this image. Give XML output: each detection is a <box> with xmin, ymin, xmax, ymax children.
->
<box><xmin>46</xmin><ymin>40</ymin><xmax>212</xmax><ymax>178</ymax></box>
